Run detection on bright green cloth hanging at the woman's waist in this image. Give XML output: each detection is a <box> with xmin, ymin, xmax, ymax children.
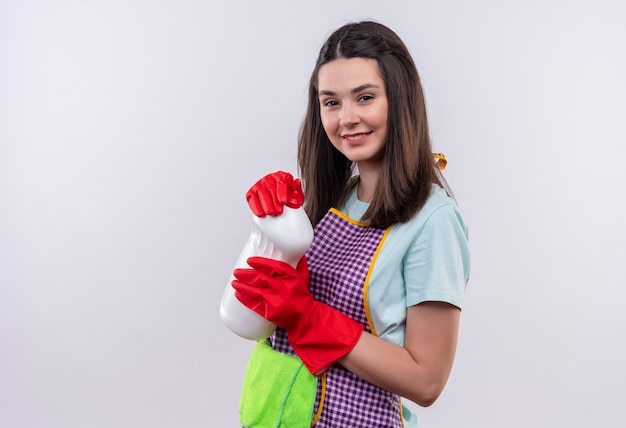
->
<box><xmin>239</xmin><ymin>340</ymin><xmax>317</xmax><ymax>428</ymax></box>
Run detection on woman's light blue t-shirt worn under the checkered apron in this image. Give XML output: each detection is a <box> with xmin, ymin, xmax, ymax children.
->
<box><xmin>339</xmin><ymin>185</ymin><xmax>470</xmax><ymax>428</ymax></box>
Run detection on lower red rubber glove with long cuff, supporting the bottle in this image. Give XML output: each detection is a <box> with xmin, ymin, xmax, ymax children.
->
<box><xmin>232</xmin><ymin>257</ymin><xmax>363</xmax><ymax>376</ymax></box>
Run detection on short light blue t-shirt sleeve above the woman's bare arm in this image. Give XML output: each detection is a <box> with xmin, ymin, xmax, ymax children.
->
<box><xmin>404</xmin><ymin>204</ymin><xmax>470</xmax><ymax>308</ymax></box>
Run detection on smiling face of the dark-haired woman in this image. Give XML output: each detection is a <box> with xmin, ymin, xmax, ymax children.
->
<box><xmin>317</xmin><ymin>58</ymin><xmax>388</xmax><ymax>169</ymax></box>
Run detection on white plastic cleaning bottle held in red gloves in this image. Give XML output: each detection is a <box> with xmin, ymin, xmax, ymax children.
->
<box><xmin>220</xmin><ymin>206</ymin><xmax>313</xmax><ymax>340</ymax></box>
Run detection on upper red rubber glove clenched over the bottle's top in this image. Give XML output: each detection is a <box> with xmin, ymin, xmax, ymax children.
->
<box><xmin>246</xmin><ymin>171</ymin><xmax>304</xmax><ymax>217</ymax></box>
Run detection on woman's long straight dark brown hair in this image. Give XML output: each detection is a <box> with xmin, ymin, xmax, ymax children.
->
<box><xmin>298</xmin><ymin>21</ymin><xmax>447</xmax><ymax>227</ymax></box>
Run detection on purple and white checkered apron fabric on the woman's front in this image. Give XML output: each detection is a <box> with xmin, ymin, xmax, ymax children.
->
<box><xmin>271</xmin><ymin>211</ymin><xmax>402</xmax><ymax>428</ymax></box>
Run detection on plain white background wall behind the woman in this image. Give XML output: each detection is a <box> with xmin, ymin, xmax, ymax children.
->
<box><xmin>0</xmin><ymin>0</ymin><xmax>626</xmax><ymax>428</ymax></box>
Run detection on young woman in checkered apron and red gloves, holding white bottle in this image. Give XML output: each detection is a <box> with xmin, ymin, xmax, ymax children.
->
<box><xmin>233</xmin><ymin>22</ymin><xmax>469</xmax><ymax>428</ymax></box>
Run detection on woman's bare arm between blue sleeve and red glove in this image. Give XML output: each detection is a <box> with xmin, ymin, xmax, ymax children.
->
<box><xmin>338</xmin><ymin>302</ymin><xmax>461</xmax><ymax>407</ymax></box>
